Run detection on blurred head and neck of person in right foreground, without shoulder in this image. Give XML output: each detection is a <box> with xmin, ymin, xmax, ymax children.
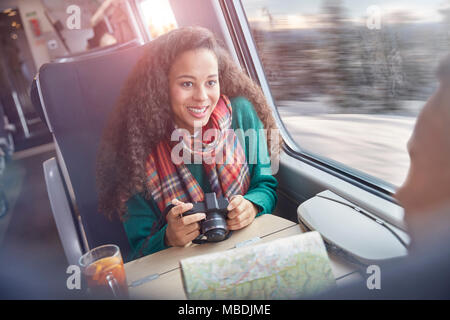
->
<box><xmin>395</xmin><ymin>55</ymin><xmax>450</xmax><ymax>252</ymax></box>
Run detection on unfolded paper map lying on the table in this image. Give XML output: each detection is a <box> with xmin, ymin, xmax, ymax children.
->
<box><xmin>180</xmin><ymin>231</ymin><xmax>336</xmax><ymax>299</ymax></box>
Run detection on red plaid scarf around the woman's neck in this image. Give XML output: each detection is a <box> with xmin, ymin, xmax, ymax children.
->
<box><xmin>146</xmin><ymin>95</ymin><xmax>250</xmax><ymax>216</ymax></box>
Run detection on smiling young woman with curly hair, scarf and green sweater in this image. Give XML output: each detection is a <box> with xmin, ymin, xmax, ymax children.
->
<box><xmin>97</xmin><ymin>27</ymin><xmax>281</xmax><ymax>258</ymax></box>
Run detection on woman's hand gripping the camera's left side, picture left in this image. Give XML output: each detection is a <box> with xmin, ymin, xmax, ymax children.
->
<box><xmin>165</xmin><ymin>199</ymin><xmax>206</xmax><ymax>247</ymax></box>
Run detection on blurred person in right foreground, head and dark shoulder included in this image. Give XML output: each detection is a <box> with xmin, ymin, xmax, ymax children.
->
<box><xmin>320</xmin><ymin>55</ymin><xmax>450</xmax><ymax>299</ymax></box>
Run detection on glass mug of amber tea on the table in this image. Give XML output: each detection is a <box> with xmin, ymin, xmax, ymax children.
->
<box><xmin>79</xmin><ymin>244</ymin><xmax>128</xmax><ymax>299</ymax></box>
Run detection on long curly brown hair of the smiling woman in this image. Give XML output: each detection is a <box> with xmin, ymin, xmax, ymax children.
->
<box><xmin>96</xmin><ymin>27</ymin><xmax>283</xmax><ymax>220</ymax></box>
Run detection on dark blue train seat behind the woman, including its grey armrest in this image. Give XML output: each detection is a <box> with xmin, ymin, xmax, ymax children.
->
<box><xmin>32</xmin><ymin>45</ymin><xmax>145</xmax><ymax>264</ymax></box>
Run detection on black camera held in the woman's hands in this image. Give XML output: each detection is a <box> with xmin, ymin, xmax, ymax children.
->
<box><xmin>183</xmin><ymin>192</ymin><xmax>231</xmax><ymax>243</ymax></box>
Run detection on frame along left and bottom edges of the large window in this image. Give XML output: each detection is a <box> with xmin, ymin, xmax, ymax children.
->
<box><xmin>219</xmin><ymin>0</ymin><xmax>399</xmax><ymax>205</ymax></box>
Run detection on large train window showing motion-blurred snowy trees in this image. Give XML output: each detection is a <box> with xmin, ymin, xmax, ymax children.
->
<box><xmin>234</xmin><ymin>0</ymin><xmax>450</xmax><ymax>193</ymax></box>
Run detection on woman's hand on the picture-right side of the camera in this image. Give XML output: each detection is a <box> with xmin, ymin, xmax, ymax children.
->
<box><xmin>227</xmin><ymin>195</ymin><xmax>258</xmax><ymax>230</ymax></box>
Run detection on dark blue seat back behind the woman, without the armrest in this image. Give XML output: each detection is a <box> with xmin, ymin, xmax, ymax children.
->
<box><xmin>37</xmin><ymin>45</ymin><xmax>146</xmax><ymax>259</ymax></box>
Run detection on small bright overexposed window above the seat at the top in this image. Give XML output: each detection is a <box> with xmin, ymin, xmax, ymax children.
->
<box><xmin>136</xmin><ymin>0</ymin><xmax>177</xmax><ymax>40</ymax></box>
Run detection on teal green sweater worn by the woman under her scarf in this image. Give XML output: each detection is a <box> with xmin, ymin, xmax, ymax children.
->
<box><xmin>124</xmin><ymin>97</ymin><xmax>278</xmax><ymax>259</ymax></box>
